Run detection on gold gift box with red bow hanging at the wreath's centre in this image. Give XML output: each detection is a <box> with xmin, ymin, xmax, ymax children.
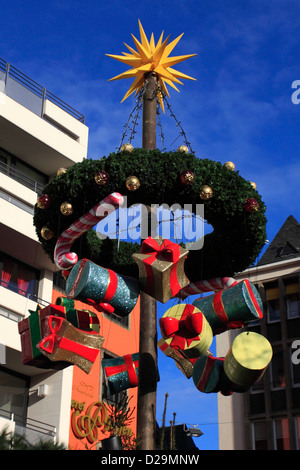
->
<box><xmin>132</xmin><ymin>237</ymin><xmax>189</xmax><ymax>303</ymax></box>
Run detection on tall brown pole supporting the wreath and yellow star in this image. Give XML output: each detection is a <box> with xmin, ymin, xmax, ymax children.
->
<box><xmin>137</xmin><ymin>73</ymin><xmax>158</xmax><ymax>450</ymax></box>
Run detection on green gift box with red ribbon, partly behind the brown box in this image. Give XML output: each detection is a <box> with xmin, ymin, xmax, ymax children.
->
<box><xmin>18</xmin><ymin>298</ymin><xmax>100</xmax><ymax>369</ymax></box>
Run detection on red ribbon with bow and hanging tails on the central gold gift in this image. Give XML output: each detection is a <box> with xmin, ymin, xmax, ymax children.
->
<box><xmin>141</xmin><ymin>237</ymin><xmax>181</xmax><ymax>296</ymax></box>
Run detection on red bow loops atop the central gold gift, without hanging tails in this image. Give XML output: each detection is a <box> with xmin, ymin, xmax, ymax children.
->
<box><xmin>141</xmin><ymin>237</ymin><xmax>180</xmax><ymax>265</ymax></box>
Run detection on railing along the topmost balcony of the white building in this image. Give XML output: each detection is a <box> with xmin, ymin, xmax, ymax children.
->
<box><xmin>0</xmin><ymin>57</ymin><xmax>85</xmax><ymax>123</ymax></box>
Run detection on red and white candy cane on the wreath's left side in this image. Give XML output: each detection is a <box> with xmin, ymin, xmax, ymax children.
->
<box><xmin>54</xmin><ymin>193</ymin><xmax>124</xmax><ymax>269</ymax></box>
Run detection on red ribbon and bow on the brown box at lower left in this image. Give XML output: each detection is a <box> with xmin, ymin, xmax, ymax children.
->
<box><xmin>39</xmin><ymin>315</ymin><xmax>99</xmax><ymax>362</ymax></box>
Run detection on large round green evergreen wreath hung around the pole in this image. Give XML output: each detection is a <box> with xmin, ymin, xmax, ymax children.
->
<box><xmin>34</xmin><ymin>148</ymin><xmax>266</xmax><ymax>282</ymax></box>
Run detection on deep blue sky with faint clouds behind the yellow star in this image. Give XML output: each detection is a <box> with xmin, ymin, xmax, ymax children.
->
<box><xmin>0</xmin><ymin>0</ymin><xmax>300</xmax><ymax>449</ymax></box>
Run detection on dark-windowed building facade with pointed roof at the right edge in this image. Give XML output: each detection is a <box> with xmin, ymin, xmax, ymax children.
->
<box><xmin>217</xmin><ymin>216</ymin><xmax>300</xmax><ymax>450</ymax></box>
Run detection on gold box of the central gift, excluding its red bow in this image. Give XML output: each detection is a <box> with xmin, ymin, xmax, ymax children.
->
<box><xmin>132</xmin><ymin>238</ymin><xmax>190</xmax><ymax>303</ymax></box>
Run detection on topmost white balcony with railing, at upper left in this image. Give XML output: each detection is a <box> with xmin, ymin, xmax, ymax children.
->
<box><xmin>0</xmin><ymin>58</ymin><xmax>88</xmax><ymax>176</ymax></box>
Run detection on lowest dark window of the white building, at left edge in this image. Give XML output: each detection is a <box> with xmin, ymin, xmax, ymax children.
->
<box><xmin>0</xmin><ymin>366</ymin><xmax>29</xmax><ymax>426</ymax></box>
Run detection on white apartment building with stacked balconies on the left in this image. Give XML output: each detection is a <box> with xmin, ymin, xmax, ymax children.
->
<box><xmin>0</xmin><ymin>59</ymin><xmax>88</xmax><ymax>444</ymax></box>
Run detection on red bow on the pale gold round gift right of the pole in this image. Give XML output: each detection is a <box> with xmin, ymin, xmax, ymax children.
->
<box><xmin>159</xmin><ymin>305</ymin><xmax>203</xmax><ymax>349</ymax></box>
